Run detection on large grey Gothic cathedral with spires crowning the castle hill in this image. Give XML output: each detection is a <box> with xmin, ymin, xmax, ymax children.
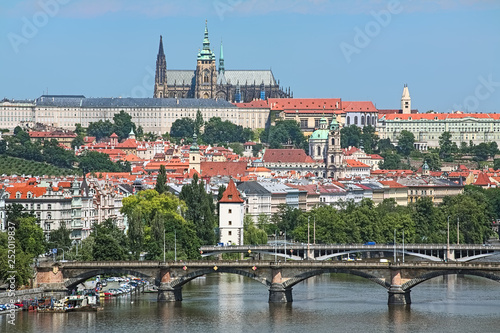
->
<box><xmin>153</xmin><ymin>22</ymin><xmax>293</xmax><ymax>103</ymax></box>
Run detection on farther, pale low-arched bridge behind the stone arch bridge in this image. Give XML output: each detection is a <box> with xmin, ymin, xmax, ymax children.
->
<box><xmin>200</xmin><ymin>243</ymin><xmax>500</xmax><ymax>262</ymax></box>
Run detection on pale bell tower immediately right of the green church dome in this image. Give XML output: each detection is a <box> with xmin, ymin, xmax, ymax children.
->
<box><xmin>326</xmin><ymin>116</ymin><xmax>346</xmax><ymax>179</ymax></box>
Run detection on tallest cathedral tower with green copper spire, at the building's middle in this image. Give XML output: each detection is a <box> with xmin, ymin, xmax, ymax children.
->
<box><xmin>195</xmin><ymin>21</ymin><xmax>217</xmax><ymax>98</ymax></box>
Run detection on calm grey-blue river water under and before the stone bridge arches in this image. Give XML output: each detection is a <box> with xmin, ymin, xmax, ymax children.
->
<box><xmin>0</xmin><ymin>274</ymin><xmax>500</xmax><ymax>333</ymax></box>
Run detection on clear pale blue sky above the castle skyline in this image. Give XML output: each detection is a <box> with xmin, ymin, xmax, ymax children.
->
<box><xmin>0</xmin><ymin>0</ymin><xmax>500</xmax><ymax>112</ymax></box>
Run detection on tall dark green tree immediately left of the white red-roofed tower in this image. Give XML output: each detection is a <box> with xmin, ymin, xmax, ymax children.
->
<box><xmin>179</xmin><ymin>174</ymin><xmax>217</xmax><ymax>245</ymax></box>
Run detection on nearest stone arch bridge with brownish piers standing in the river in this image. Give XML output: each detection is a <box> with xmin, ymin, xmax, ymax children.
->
<box><xmin>35</xmin><ymin>260</ymin><xmax>500</xmax><ymax>304</ymax></box>
